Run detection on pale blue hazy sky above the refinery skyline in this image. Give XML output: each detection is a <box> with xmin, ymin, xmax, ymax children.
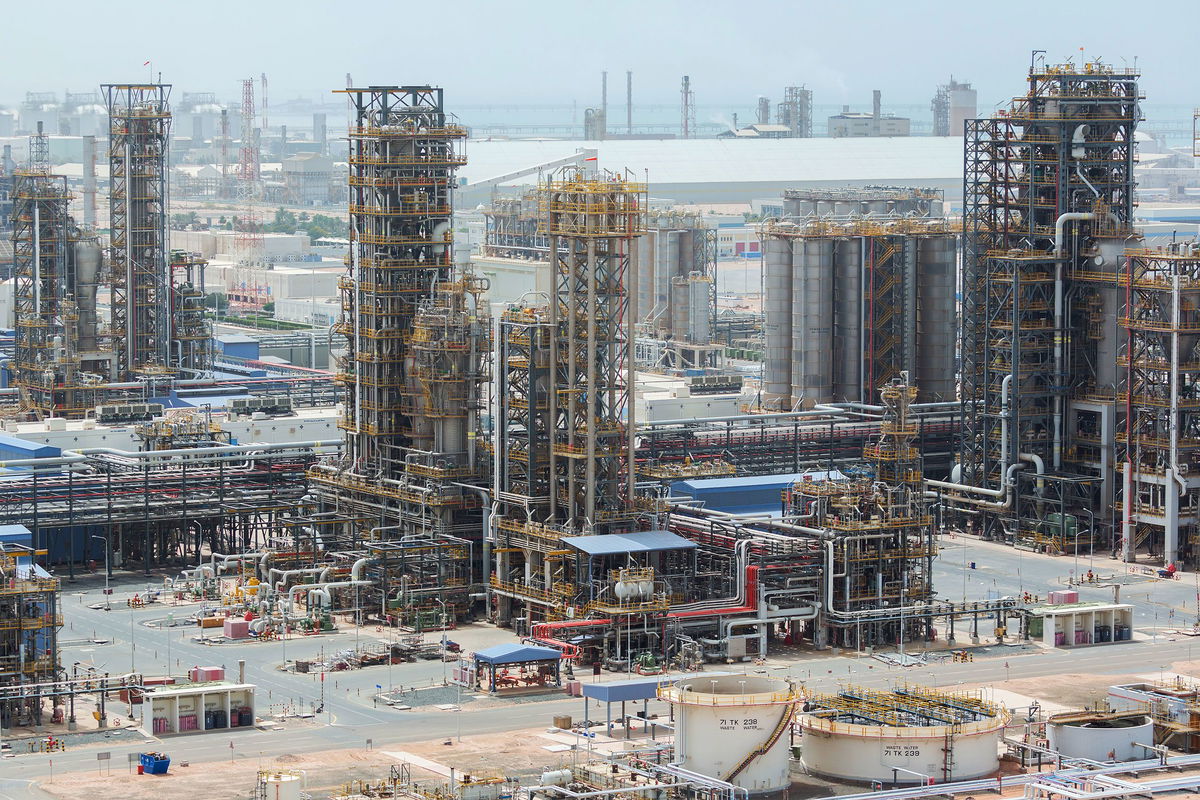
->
<box><xmin>0</xmin><ymin>0</ymin><xmax>1200</xmax><ymax>112</ymax></box>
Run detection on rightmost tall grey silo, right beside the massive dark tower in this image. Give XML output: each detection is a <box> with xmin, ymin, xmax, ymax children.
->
<box><xmin>913</xmin><ymin>234</ymin><xmax>958</xmax><ymax>403</ymax></box>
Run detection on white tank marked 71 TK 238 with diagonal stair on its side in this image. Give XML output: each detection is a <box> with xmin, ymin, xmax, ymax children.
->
<box><xmin>659</xmin><ymin>675</ymin><xmax>799</xmax><ymax>794</ymax></box>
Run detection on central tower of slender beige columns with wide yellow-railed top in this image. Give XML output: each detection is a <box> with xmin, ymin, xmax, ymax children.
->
<box><xmin>541</xmin><ymin>168</ymin><xmax>647</xmax><ymax>533</ymax></box>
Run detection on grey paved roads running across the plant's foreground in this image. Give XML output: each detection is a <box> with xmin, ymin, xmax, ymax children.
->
<box><xmin>0</xmin><ymin>537</ymin><xmax>1196</xmax><ymax>800</ymax></box>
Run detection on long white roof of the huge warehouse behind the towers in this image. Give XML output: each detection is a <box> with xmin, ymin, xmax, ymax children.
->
<box><xmin>458</xmin><ymin>137</ymin><xmax>962</xmax><ymax>193</ymax></box>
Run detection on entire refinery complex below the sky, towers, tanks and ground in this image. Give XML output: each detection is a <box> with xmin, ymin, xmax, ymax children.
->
<box><xmin>0</xmin><ymin>25</ymin><xmax>1200</xmax><ymax>800</ymax></box>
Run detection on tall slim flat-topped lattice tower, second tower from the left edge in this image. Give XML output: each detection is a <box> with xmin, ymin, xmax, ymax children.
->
<box><xmin>101</xmin><ymin>84</ymin><xmax>170</xmax><ymax>380</ymax></box>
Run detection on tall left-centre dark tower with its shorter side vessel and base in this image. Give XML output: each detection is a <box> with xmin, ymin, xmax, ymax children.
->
<box><xmin>310</xmin><ymin>86</ymin><xmax>491</xmax><ymax>624</ymax></box>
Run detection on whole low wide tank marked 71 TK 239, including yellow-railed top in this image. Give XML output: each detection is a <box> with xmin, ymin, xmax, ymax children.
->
<box><xmin>799</xmin><ymin>686</ymin><xmax>1009</xmax><ymax>783</ymax></box>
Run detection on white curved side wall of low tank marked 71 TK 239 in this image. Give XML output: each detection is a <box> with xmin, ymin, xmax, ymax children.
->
<box><xmin>799</xmin><ymin>710</ymin><xmax>1008</xmax><ymax>783</ymax></box>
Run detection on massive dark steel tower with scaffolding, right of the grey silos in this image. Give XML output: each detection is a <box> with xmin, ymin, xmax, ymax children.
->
<box><xmin>952</xmin><ymin>59</ymin><xmax>1140</xmax><ymax>541</ymax></box>
